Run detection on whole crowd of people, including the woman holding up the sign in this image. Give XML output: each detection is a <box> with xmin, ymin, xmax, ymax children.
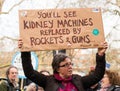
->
<box><xmin>0</xmin><ymin>40</ymin><xmax>120</xmax><ymax>91</ymax></box>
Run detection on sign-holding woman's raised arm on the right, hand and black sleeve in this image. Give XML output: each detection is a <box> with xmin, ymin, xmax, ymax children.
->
<box><xmin>82</xmin><ymin>42</ymin><xmax>108</xmax><ymax>89</ymax></box>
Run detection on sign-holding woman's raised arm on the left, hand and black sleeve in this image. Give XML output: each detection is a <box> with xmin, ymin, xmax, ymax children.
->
<box><xmin>18</xmin><ymin>39</ymin><xmax>46</xmax><ymax>87</ymax></box>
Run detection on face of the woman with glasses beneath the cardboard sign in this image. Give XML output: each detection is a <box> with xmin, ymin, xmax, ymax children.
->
<box><xmin>58</xmin><ymin>58</ymin><xmax>73</xmax><ymax>79</ymax></box>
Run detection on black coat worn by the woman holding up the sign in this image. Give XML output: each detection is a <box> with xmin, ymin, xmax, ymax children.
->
<box><xmin>21</xmin><ymin>52</ymin><xmax>106</xmax><ymax>91</ymax></box>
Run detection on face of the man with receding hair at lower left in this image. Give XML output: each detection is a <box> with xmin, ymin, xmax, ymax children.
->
<box><xmin>8</xmin><ymin>68</ymin><xmax>18</xmax><ymax>81</ymax></box>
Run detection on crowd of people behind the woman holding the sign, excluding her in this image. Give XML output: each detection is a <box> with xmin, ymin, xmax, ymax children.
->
<box><xmin>0</xmin><ymin>66</ymin><xmax>120</xmax><ymax>91</ymax></box>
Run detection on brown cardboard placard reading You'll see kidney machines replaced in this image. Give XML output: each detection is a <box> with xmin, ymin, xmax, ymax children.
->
<box><xmin>19</xmin><ymin>8</ymin><xmax>105</xmax><ymax>51</ymax></box>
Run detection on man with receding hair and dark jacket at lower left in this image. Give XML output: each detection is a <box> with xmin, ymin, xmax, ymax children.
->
<box><xmin>0</xmin><ymin>66</ymin><xmax>21</xmax><ymax>91</ymax></box>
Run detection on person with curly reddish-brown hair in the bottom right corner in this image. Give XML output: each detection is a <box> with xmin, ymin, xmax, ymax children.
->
<box><xmin>98</xmin><ymin>70</ymin><xmax>120</xmax><ymax>91</ymax></box>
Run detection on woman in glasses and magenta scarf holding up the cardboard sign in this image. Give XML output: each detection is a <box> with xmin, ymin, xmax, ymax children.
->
<box><xmin>18</xmin><ymin>39</ymin><xmax>108</xmax><ymax>91</ymax></box>
